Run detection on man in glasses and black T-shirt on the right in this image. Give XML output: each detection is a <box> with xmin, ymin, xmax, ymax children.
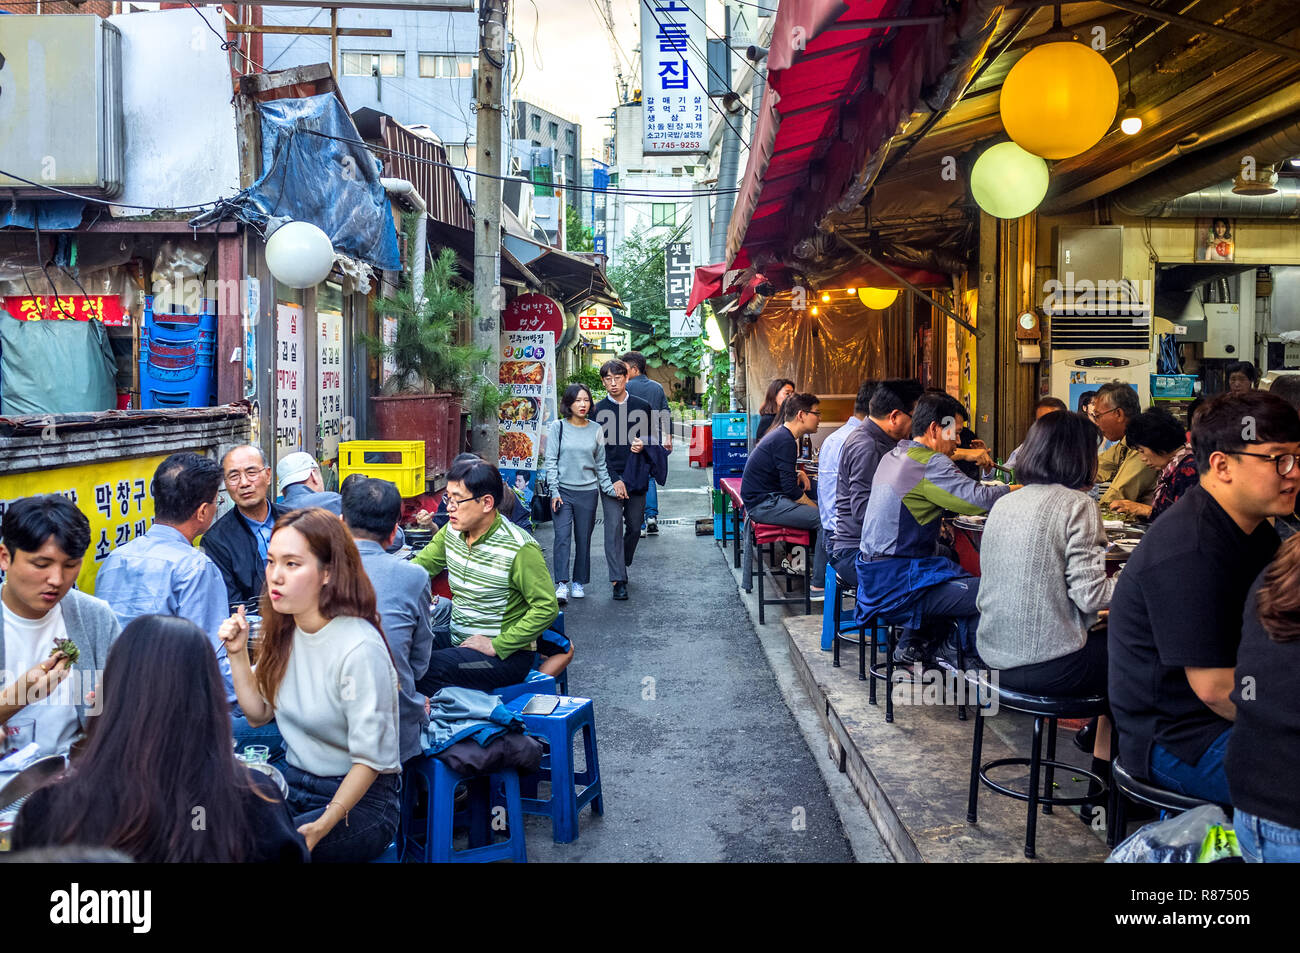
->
<box><xmin>1099</xmin><ymin>391</ymin><xmax>1300</xmax><ymax>805</ymax></box>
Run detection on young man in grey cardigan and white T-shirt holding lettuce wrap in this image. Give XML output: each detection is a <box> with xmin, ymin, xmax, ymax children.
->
<box><xmin>0</xmin><ymin>495</ymin><xmax>121</xmax><ymax>761</ymax></box>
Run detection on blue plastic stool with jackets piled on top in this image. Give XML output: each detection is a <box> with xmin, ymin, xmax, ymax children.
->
<box><xmin>402</xmin><ymin>754</ymin><xmax>528</xmax><ymax>863</ymax></box>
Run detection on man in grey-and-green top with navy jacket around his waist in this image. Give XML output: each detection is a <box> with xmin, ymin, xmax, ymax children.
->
<box><xmin>855</xmin><ymin>391</ymin><xmax>1010</xmax><ymax>671</ymax></box>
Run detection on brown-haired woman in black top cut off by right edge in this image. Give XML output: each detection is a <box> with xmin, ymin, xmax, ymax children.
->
<box><xmin>1223</xmin><ymin>536</ymin><xmax>1300</xmax><ymax>863</ymax></box>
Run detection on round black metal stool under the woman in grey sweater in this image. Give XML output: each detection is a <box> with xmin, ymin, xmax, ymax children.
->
<box><xmin>966</xmin><ymin>675</ymin><xmax>1108</xmax><ymax>859</ymax></box>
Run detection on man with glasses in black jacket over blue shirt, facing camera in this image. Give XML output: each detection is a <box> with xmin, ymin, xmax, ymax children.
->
<box><xmin>199</xmin><ymin>445</ymin><xmax>289</xmax><ymax>606</ymax></box>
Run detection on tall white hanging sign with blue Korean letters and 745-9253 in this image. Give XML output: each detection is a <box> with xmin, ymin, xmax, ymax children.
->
<box><xmin>641</xmin><ymin>0</ymin><xmax>709</xmax><ymax>156</ymax></box>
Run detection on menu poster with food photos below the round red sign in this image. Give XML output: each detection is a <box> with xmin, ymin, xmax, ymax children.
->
<box><xmin>498</xmin><ymin>332</ymin><xmax>555</xmax><ymax>471</ymax></box>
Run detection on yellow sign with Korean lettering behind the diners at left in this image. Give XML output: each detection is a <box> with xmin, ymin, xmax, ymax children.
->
<box><xmin>0</xmin><ymin>454</ymin><xmax>166</xmax><ymax>593</ymax></box>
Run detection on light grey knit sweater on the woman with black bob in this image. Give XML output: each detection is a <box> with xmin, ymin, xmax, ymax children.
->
<box><xmin>976</xmin><ymin>484</ymin><xmax>1115</xmax><ymax>668</ymax></box>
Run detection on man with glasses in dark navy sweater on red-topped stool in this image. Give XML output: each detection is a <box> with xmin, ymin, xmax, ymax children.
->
<box><xmin>740</xmin><ymin>394</ymin><xmax>826</xmax><ymax>592</ymax></box>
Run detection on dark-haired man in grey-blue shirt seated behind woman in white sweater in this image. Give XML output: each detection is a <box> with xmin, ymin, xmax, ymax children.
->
<box><xmin>342</xmin><ymin>477</ymin><xmax>433</xmax><ymax>762</ymax></box>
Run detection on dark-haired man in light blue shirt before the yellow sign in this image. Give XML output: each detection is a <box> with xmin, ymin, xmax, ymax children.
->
<box><xmin>95</xmin><ymin>452</ymin><xmax>235</xmax><ymax>686</ymax></box>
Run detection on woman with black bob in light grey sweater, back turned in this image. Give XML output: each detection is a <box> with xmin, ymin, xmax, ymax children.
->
<box><xmin>976</xmin><ymin>413</ymin><xmax>1115</xmax><ymax>761</ymax></box>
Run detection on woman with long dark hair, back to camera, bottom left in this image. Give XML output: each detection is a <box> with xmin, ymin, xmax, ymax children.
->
<box><xmin>13</xmin><ymin>613</ymin><xmax>308</xmax><ymax>863</ymax></box>
